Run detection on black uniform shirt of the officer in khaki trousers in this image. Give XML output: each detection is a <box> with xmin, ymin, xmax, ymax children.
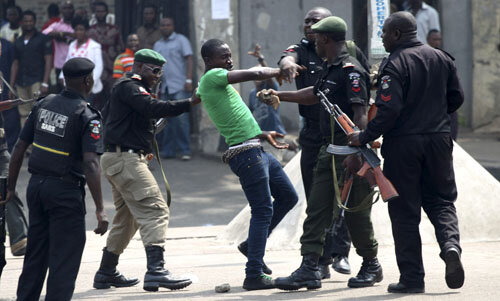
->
<box><xmin>103</xmin><ymin>73</ymin><xmax>190</xmax><ymax>154</ymax></box>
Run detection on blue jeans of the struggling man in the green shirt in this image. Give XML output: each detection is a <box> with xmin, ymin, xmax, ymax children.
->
<box><xmin>229</xmin><ymin>148</ymin><xmax>298</xmax><ymax>277</ymax></box>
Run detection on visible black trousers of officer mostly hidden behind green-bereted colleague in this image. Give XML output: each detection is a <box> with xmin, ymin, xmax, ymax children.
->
<box><xmin>299</xmin><ymin>123</ymin><xmax>351</xmax><ymax>264</ymax></box>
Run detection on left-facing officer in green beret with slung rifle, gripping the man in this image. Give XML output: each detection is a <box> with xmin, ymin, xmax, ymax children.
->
<box><xmin>272</xmin><ymin>16</ymin><xmax>382</xmax><ymax>290</ymax></box>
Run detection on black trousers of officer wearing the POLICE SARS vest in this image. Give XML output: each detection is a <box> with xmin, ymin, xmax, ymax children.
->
<box><xmin>17</xmin><ymin>175</ymin><xmax>85</xmax><ymax>300</ymax></box>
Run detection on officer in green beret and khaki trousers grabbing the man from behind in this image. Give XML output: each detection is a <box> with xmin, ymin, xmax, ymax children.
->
<box><xmin>94</xmin><ymin>49</ymin><xmax>199</xmax><ymax>291</ymax></box>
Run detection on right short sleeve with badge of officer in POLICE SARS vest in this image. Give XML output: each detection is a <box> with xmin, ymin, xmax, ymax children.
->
<box><xmin>81</xmin><ymin>112</ymin><xmax>104</xmax><ymax>154</ymax></box>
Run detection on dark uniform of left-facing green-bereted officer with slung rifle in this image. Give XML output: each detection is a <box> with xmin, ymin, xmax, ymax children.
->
<box><xmin>300</xmin><ymin>48</ymin><xmax>378</xmax><ymax>259</ymax></box>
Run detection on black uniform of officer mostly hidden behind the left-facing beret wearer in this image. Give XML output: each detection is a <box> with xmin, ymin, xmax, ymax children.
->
<box><xmin>281</xmin><ymin>38</ymin><xmax>370</xmax><ymax>264</ymax></box>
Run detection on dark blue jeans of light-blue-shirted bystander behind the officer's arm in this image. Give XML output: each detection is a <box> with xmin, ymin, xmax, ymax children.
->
<box><xmin>158</xmin><ymin>90</ymin><xmax>191</xmax><ymax>157</ymax></box>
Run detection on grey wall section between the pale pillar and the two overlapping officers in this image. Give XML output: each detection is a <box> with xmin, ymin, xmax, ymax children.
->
<box><xmin>237</xmin><ymin>0</ymin><xmax>352</xmax><ymax>132</ymax></box>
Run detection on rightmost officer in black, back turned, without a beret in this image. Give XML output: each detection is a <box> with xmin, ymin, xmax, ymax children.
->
<box><xmin>349</xmin><ymin>12</ymin><xmax>464</xmax><ymax>293</ymax></box>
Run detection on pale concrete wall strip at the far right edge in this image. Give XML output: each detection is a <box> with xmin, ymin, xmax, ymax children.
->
<box><xmin>471</xmin><ymin>0</ymin><xmax>500</xmax><ymax>132</ymax></box>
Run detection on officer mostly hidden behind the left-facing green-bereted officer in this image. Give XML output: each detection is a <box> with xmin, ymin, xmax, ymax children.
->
<box><xmin>279</xmin><ymin>7</ymin><xmax>370</xmax><ymax>279</ymax></box>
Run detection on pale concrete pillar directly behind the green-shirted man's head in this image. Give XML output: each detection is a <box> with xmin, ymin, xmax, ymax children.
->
<box><xmin>191</xmin><ymin>0</ymin><xmax>240</xmax><ymax>153</ymax></box>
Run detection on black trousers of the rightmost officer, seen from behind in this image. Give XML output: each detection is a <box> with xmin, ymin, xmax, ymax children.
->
<box><xmin>382</xmin><ymin>133</ymin><xmax>461</xmax><ymax>286</ymax></box>
